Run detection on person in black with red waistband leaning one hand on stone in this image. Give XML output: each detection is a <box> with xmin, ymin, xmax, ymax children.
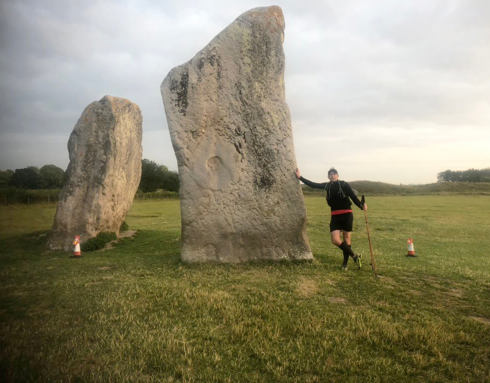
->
<box><xmin>296</xmin><ymin>168</ymin><xmax>367</xmax><ymax>270</ymax></box>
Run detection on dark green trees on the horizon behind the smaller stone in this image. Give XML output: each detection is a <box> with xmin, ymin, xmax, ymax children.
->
<box><xmin>0</xmin><ymin>159</ymin><xmax>179</xmax><ymax>193</ymax></box>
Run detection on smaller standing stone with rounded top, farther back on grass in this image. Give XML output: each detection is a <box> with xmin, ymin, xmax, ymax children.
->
<box><xmin>48</xmin><ymin>96</ymin><xmax>142</xmax><ymax>250</ymax></box>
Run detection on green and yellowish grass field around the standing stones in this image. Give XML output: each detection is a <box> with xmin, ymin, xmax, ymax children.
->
<box><xmin>0</xmin><ymin>196</ymin><xmax>490</xmax><ymax>382</ymax></box>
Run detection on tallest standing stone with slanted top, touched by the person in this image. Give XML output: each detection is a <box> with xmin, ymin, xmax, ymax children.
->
<box><xmin>161</xmin><ymin>6</ymin><xmax>312</xmax><ymax>262</ymax></box>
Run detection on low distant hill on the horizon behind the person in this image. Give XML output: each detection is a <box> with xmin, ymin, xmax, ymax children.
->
<box><xmin>303</xmin><ymin>181</ymin><xmax>490</xmax><ymax>195</ymax></box>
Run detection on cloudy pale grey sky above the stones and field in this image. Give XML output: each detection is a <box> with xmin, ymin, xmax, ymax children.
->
<box><xmin>0</xmin><ymin>0</ymin><xmax>490</xmax><ymax>184</ymax></box>
